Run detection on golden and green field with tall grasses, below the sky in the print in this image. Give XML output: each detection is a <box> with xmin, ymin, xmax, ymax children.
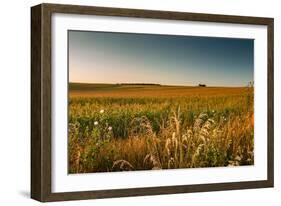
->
<box><xmin>68</xmin><ymin>83</ymin><xmax>254</xmax><ymax>173</ymax></box>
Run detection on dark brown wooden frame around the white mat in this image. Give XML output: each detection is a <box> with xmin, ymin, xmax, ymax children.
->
<box><xmin>31</xmin><ymin>4</ymin><xmax>274</xmax><ymax>202</ymax></box>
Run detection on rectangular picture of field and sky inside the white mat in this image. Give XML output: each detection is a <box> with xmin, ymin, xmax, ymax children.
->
<box><xmin>67</xmin><ymin>30</ymin><xmax>254</xmax><ymax>174</ymax></box>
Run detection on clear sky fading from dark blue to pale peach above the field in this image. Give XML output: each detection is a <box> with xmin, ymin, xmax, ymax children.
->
<box><xmin>68</xmin><ymin>31</ymin><xmax>254</xmax><ymax>87</ymax></box>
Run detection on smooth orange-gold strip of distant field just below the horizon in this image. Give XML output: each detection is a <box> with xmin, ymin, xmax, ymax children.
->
<box><xmin>70</xmin><ymin>84</ymin><xmax>249</xmax><ymax>98</ymax></box>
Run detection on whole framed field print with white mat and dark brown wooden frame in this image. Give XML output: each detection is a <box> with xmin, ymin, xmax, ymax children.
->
<box><xmin>31</xmin><ymin>4</ymin><xmax>274</xmax><ymax>202</ymax></box>
